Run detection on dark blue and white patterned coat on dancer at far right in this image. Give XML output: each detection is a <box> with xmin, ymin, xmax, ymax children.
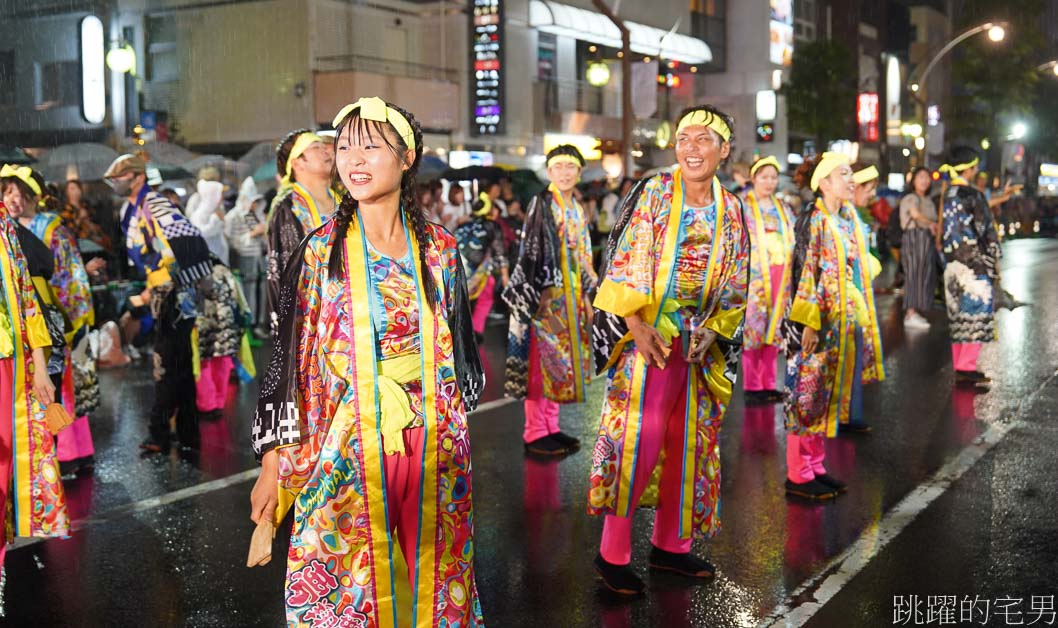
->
<box><xmin>942</xmin><ymin>179</ymin><xmax>1001</xmax><ymax>344</ymax></box>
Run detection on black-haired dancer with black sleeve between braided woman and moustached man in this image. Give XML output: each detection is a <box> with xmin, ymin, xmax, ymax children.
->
<box><xmin>503</xmin><ymin>144</ymin><xmax>599</xmax><ymax>456</ymax></box>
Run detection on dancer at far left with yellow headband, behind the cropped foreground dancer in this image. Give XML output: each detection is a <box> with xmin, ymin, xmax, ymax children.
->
<box><xmin>0</xmin><ymin>166</ymin><xmax>95</xmax><ymax>475</ymax></box>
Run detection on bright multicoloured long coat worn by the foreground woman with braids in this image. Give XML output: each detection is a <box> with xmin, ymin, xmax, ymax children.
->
<box><xmin>253</xmin><ymin>218</ymin><xmax>484</xmax><ymax>627</ymax></box>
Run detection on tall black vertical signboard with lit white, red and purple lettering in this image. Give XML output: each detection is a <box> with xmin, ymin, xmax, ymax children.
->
<box><xmin>469</xmin><ymin>0</ymin><xmax>507</xmax><ymax>135</ymax></box>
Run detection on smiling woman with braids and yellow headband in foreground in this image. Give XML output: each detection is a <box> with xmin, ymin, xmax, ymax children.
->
<box><xmin>251</xmin><ymin>98</ymin><xmax>484</xmax><ymax>627</ymax></box>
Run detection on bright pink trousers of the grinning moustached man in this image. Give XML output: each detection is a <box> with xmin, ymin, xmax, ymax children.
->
<box><xmin>599</xmin><ymin>338</ymin><xmax>692</xmax><ymax>565</ymax></box>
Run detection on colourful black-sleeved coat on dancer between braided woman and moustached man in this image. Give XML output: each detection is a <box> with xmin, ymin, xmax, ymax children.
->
<box><xmin>504</xmin><ymin>185</ymin><xmax>599</xmax><ymax>403</ymax></box>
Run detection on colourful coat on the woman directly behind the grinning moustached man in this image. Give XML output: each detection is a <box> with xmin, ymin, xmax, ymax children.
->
<box><xmin>742</xmin><ymin>191</ymin><xmax>794</xmax><ymax>349</ymax></box>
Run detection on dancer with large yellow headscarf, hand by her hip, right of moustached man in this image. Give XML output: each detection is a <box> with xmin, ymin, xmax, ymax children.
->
<box><xmin>784</xmin><ymin>152</ymin><xmax>878</xmax><ymax>499</ymax></box>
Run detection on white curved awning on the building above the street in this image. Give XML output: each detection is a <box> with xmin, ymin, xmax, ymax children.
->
<box><xmin>529</xmin><ymin>0</ymin><xmax>713</xmax><ymax>63</ymax></box>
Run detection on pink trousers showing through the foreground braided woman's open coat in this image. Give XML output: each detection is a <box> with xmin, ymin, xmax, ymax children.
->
<box><xmin>385</xmin><ymin>427</ymin><xmax>430</xmax><ymax>588</ymax></box>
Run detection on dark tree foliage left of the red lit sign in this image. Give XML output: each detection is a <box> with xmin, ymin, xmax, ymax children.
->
<box><xmin>780</xmin><ymin>40</ymin><xmax>857</xmax><ymax>149</ymax></box>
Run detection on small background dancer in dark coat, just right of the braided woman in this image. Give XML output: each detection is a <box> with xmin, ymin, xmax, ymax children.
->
<box><xmin>454</xmin><ymin>192</ymin><xmax>509</xmax><ymax>343</ymax></box>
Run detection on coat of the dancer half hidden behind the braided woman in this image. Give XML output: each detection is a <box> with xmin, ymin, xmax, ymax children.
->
<box><xmin>266</xmin><ymin>183</ymin><xmax>338</xmax><ymax>334</ymax></box>
